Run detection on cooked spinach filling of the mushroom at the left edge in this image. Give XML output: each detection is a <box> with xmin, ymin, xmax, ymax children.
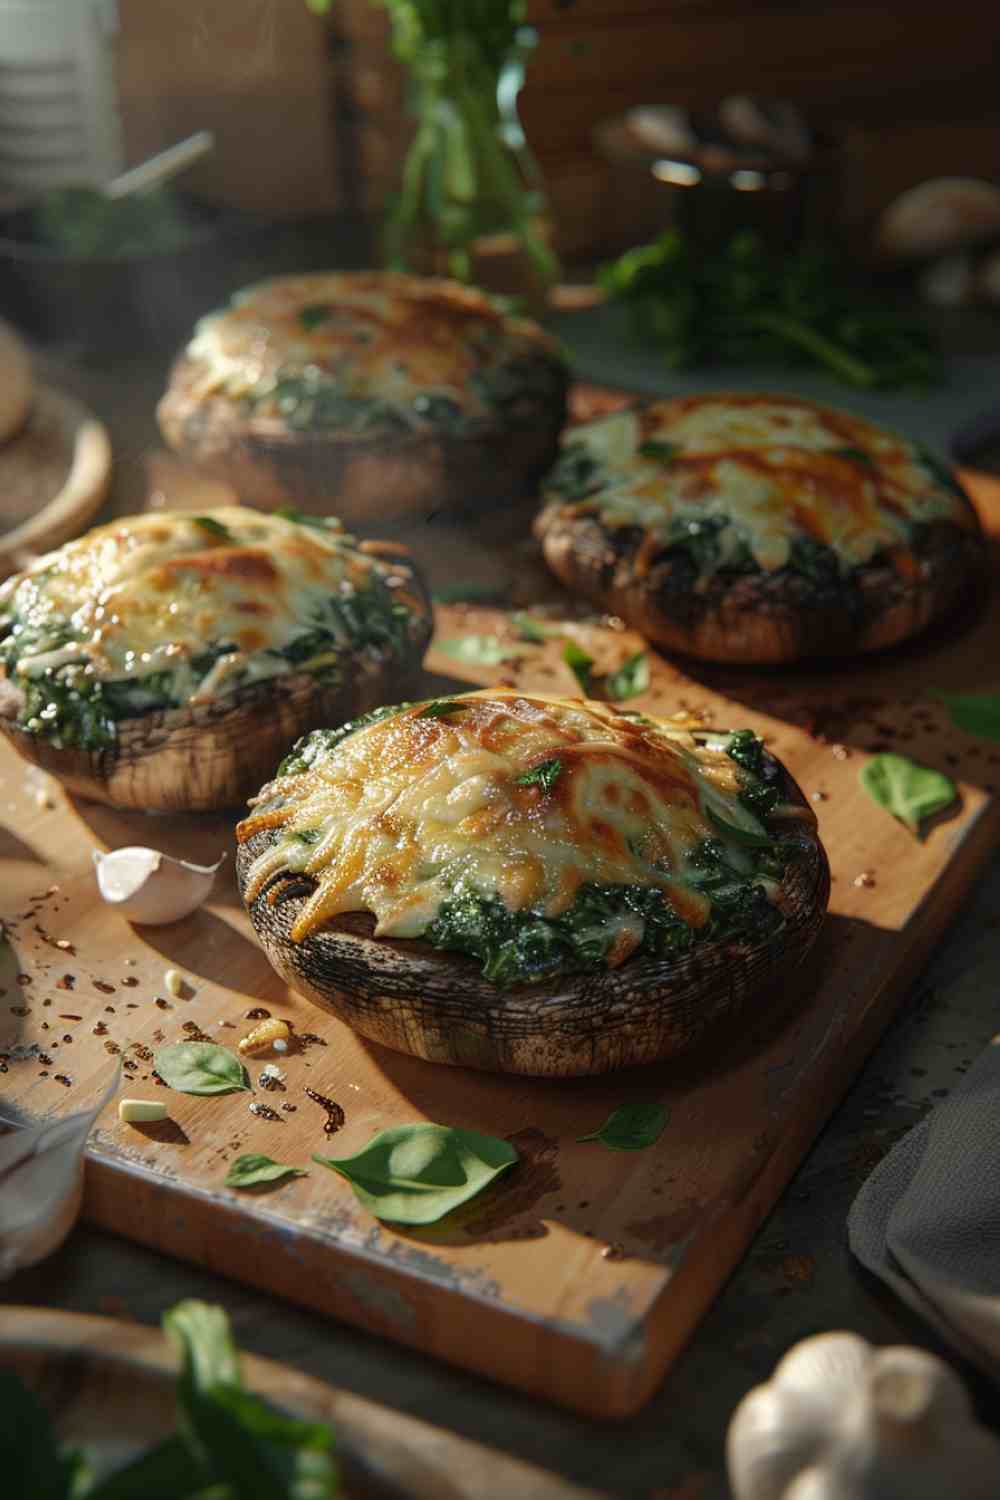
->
<box><xmin>0</xmin><ymin>534</ymin><xmax>409</xmax><ymax>750</ymax></box>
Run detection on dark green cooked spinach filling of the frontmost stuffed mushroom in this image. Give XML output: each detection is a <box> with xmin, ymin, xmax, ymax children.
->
<box><xmin>268</xmin><ymin>720</ymin><xmax>801</xmax><ymax>986</ymax></box>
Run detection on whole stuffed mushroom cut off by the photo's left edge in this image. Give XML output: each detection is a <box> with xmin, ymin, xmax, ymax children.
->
<box><xmin>0</xmin><ymin>506</ymin><xmax>430</xmax><ymax>812</ymax></box>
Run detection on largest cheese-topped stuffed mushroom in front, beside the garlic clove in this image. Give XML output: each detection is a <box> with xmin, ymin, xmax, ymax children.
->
<box><xmin>237</xmin><ymin>689</ymin><xmax>829</xmax><ymax>1076</ymax></box>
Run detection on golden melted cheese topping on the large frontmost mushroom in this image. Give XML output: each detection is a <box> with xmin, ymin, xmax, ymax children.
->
<box><xmin>238</xmin><ymin>689</ymin><xmax>763</xmax><ymax>957</ymax></box>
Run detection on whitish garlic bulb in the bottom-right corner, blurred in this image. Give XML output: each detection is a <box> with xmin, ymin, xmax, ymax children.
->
<box><xmin>726</xmin><ymin>1334</ymin><xmax>1000</xmax><ymax>1500</ymax></box>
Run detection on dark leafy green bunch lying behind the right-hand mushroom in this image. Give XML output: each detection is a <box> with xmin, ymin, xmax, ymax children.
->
<box><xmin>598</xmin><ymin>230</ymin><xmax>940</xmax><ymax>389</ymax></box>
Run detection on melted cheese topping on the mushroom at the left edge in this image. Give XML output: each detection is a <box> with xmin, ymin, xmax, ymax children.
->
<box><xmin>0</xmin><ymin>506</ymin><xmax>421</xmax><ymax>702</ymax></box>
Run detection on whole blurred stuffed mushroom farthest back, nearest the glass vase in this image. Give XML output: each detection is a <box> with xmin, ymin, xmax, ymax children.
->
<box><xmin>157</xmin><ymin>272</ymin><xmax>568</xmax><ymax>528</ymax></box>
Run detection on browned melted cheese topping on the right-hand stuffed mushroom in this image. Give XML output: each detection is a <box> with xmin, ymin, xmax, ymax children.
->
<box><xmin>565</xmin><ymin>395</ymin><xmax>972</xmax><ymax>570</ymax></box>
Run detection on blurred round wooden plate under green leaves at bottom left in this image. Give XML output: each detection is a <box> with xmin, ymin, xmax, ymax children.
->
<box><xmin>0</xmin><ymin>1307</ymin><xmax>595</xmax><ymax>1500</ymax></box>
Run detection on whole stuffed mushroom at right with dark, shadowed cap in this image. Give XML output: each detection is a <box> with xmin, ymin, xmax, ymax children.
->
<box><xmin>535</xmin><ymin>393</ymin><xmax>985</xmax><ymax>663</ymax></box>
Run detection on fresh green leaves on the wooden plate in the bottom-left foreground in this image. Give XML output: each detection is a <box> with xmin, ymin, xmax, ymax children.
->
<box><xmin>0</xmin><ymin>1301</ymin><xmax>342</xmax><ymax>1500</ymax></box>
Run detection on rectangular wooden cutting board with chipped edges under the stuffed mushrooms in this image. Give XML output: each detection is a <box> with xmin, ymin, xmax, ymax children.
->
<box><xmin>0</xmin><ymin>396</ymin><xmax>1000</xmax><ymax>1418</ymax></box>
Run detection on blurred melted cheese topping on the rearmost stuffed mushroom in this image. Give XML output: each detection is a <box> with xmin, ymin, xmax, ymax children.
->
<box><xmin>186</xmin><ymin>272</ymin><xmax>556</xmax><ymax>422</ymax></box>
